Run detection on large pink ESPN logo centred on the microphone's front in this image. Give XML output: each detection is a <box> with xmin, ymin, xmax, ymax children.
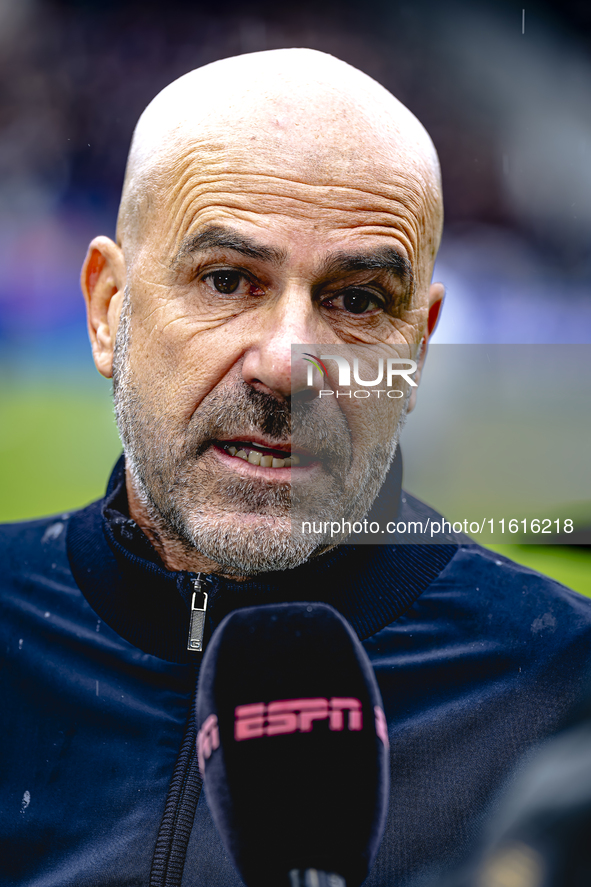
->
<box><xmin>234</xmin><ymin>696</ymin><xmax>363</xmax><ymax>741</ymax></box>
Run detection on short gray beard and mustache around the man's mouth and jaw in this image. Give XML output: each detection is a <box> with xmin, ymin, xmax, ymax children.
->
<box><xmin>113</xmin><ymin>291</ymin><xmax>406</xmax><ymax>576</ymax></box>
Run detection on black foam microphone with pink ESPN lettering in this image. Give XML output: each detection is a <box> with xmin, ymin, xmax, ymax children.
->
<box><xmin>197</xmin><ymin>603</ymin><xmax>389</xmax><ymax>887</ymax></box>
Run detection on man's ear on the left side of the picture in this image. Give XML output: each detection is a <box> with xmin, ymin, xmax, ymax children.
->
<box><xmin>80</xmin><ymin>237</ymin><xmax>126</xmax><ymax>379</ymax></box>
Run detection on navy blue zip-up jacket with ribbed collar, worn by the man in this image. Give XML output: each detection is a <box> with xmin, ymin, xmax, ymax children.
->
<box><xmin>0</xmin><ymin>463</ymin><xmax>591</xmax><ymax>887</ymax></box>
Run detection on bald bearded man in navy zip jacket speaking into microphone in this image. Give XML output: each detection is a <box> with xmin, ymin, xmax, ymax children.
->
<box><xmin>0</xmin><ymin>50</ymin><xmax>591</xmax><ymax>887</ymax></box>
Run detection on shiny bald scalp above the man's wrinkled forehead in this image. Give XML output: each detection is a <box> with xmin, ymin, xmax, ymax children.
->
<box><xmin>117</xmin><ymin>49</ymin><xmax>442</xmax><ymax>264</ymax></box>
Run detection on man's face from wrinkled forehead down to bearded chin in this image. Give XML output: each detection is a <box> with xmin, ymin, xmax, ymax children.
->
<box><xmin>108</xmin><ymin>134</ymin><xmax>440</xmax><ymax>575</ymax></box>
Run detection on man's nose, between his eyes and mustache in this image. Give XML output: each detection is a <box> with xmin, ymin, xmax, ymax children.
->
<box><xmin>242</xmin><ymin>285</ymin><xmax>327</xmax><ymax>399</ymax></box>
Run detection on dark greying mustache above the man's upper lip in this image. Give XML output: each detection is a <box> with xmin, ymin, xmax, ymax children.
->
<box><xmin>187</xmin><ymin>383</ymin><xmax>352</xmax><ymax>464</ymax></box>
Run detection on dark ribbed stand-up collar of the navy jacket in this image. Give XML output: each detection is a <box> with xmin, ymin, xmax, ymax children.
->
<box><xmin>67</xmin><ymin>456</ymin><xmax>457</xmax><ymax>663</ymax></box>
